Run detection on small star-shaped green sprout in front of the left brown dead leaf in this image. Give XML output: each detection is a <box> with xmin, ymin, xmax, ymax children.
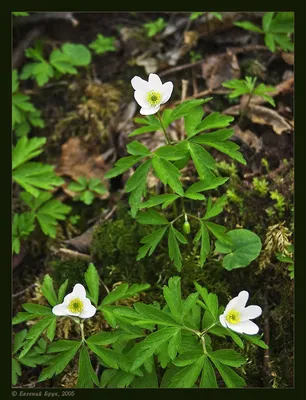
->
<box><xmin>68</xmin><ymin>176</ymin><xmax>107</xmax><ymax>205</ymax></box>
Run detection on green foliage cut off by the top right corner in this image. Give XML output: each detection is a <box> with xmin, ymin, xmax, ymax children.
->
<box><xmin>234</xmin><ymin>12</ymin><xmax>294</xmax><ymax>53</ymax></box>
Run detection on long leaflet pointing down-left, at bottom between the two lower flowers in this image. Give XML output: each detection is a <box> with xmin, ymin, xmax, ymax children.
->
<box><xmin>131</xmin><ymin>327</ymin><xmax>180</xmax><ymax>371</ymax></box>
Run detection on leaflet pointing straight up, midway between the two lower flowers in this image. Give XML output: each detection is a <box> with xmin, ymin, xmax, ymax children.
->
<box><xmin>163</xmin><ymin>276</ymin><xmax>183</xmax><ymax>324</ymax></box>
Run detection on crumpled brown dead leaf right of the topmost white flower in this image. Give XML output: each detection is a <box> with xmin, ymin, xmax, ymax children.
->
<box><xmin>202</xmin><ymin>50</ymin><xmax>240</xmax><ymax>89</ymax></box>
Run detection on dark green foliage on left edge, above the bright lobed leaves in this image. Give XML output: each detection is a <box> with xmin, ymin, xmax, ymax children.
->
<box><xmin>12</xmin><ymin>69</ymin><xmax>45</xmax><ymax>136</ymax></box>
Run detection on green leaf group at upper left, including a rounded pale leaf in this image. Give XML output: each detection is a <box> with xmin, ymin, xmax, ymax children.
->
<box><xmin>20</xmin><ymin>41</ymin><xmax>91</xmax><ymax>87</ymax></box>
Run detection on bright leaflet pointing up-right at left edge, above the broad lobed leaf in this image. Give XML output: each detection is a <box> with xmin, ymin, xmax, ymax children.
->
<box><xmin>12</xmin><ymin>137</ymin><xmax>47</xmax><ymax>170</ymax></box>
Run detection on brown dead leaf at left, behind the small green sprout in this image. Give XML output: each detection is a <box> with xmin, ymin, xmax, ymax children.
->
<box><xmin>56</xmin><ymin>137</ymin><xmax>109</xmax><ymax>199</ymax></box>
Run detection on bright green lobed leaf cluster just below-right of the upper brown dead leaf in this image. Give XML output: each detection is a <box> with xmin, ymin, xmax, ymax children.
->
<box><xmin>222</xmin><ymin>76</ymin><xmax>275</xmax><ymax>107</ymax></box>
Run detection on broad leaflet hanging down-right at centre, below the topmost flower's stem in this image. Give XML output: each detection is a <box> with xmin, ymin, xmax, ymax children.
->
<box><xmin>152</xmin><ymin>155</ymin><xmax>184</xmax><ymax>196</ymax></box>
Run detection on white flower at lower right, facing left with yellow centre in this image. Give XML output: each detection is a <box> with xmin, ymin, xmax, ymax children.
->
<box><xmin>219</xmin><ymin>290</ymin><xmax>262</xmax><ymax>335</ymax></box>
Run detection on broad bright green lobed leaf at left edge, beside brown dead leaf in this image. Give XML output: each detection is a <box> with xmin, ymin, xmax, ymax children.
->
<box><xmin>12</xmin><ymin>162</ymin><xmax>64</xmax><ymax>197</ymax></box>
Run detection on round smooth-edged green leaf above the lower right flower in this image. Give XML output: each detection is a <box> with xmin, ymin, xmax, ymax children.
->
<box><xmin>216</xmin><ymin>229</ymin><xmax>261</xmax><ymax>271</ymax></box>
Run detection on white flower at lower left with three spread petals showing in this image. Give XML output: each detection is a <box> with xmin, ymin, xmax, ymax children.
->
<box><xmin>52</xmin><ymin>283</ymin><xmax>96</xmax><ymax>318</ymax></box>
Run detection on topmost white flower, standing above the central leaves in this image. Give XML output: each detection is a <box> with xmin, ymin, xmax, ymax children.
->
<box><xmin>131</xmin><ymin>74</ymin><xmax>173</xmax><ymax>115</ymax></box>
